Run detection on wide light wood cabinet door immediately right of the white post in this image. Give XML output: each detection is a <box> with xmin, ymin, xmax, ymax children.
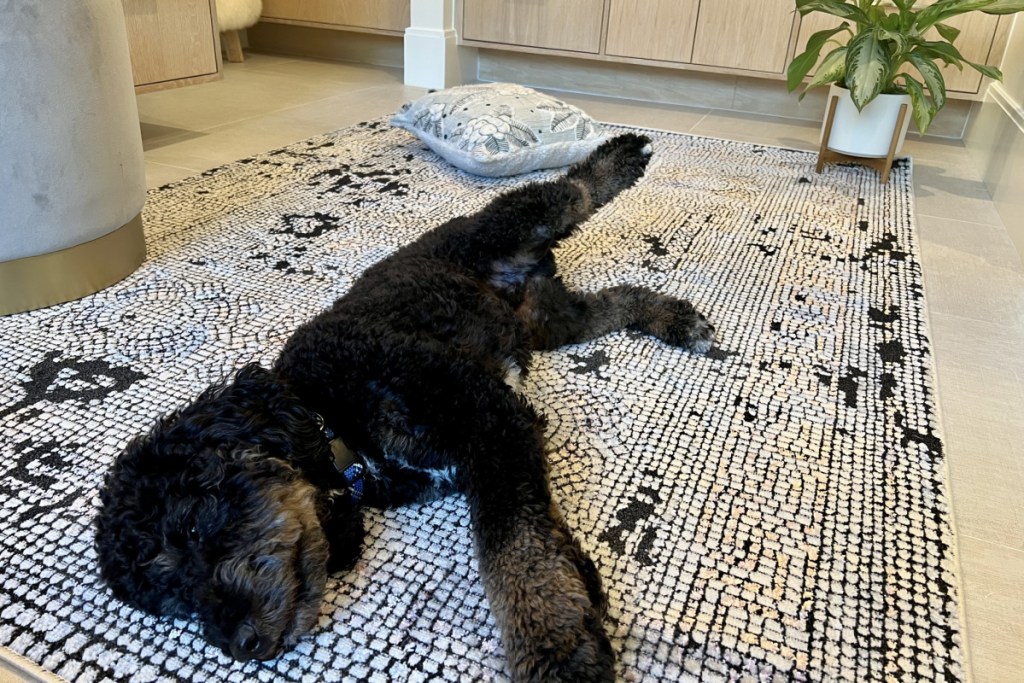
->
<box><xmin>463</xmin><ymin>0</ymin><xmax>604</xmax><ymax>53</ymax></box>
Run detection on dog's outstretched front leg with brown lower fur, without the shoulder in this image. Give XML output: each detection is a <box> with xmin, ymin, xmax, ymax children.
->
<box><xmin>464</xmin><ymin>391</ymin><xmax>614</xmax><ymax>682</ymax></box>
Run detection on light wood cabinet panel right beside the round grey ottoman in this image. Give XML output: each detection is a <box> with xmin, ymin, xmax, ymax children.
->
<box><xmin>122</xmin><ymin>0</ymin><xmax>221</xmax><ymax>92</ymax></box>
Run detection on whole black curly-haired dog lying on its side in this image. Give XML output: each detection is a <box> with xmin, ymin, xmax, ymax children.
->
<box><xmin>96</xmin><ymin>134</ymin><xmax>714</xmax><ymax>681</ymax></box>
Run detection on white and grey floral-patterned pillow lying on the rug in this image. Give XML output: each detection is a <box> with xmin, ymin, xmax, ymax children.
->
<box><xmin>391</xmin><ymin>83</ymin><xmax>607</xmax><ymax>176</ymax></box>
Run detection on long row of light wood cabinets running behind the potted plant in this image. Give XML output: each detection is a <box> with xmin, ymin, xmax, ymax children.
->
<box><xmin>460</xmin><ymin>0</ymin><xmax>1014</xmax><ymax>99</ymax></box>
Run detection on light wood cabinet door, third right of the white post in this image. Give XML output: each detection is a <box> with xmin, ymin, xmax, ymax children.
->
<box><xmin>693</xmin><ymin>0</ymin><xmax>794</xmax><ymax>74</ymax></box>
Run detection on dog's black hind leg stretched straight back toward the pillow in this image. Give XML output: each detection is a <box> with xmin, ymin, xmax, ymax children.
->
<box><xmin>405</xmin><ymin>133</ymin><xmax>651</xmax><ymax>280</ymax></box>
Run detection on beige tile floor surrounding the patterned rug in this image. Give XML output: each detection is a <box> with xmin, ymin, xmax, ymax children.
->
<box><xmin>138</xmin><ymin>54</ymin><xmax>1024</xmax><ymax>683</ymax></box>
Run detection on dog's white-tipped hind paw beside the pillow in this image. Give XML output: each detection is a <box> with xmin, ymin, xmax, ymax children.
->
<box><xmin>566</xmin><ymin>133</ymin><xmax>653</xmax><ymax>208</ymax></box>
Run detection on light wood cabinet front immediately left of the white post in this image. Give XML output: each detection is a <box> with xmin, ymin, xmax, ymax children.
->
<box><xmin>262</xmin><ymin>0</ymin><xmax>410</xmax><ymax>34</ymax></box>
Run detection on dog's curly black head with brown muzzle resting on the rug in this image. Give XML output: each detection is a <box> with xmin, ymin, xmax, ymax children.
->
<box><xmin>96</xmin><ymin>366</ymin><xmax>364</xmax><ymax>660</ymax></box>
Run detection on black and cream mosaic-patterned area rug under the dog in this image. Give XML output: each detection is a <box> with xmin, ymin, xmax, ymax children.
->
<box><xmin>0</xmin><ymin>121</ymin><xmax>965</xmax><ymax>682</ymax></box>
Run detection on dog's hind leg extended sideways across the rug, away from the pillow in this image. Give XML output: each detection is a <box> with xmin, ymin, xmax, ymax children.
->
<box><xmin>516</xmin><ymin>278</ymin><xmax>715</xmax><ymax>353</ymax></box>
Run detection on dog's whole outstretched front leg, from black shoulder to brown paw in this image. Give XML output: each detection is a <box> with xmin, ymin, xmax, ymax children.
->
<box><xmin>376</xmin><ymin>345</ymin><xmax>614</xmax><ymax>682</ymax></box>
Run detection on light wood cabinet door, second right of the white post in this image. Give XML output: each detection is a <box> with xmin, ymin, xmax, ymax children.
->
<box><xmin>604</xmin><ymin>0</ymin><xmax>700</xmax><ymax>61</ymax></box>
